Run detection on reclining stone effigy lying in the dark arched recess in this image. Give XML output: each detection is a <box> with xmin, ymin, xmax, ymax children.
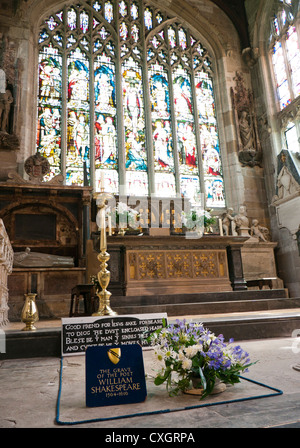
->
<box><xmin>13</xmin><ymin>247</ymin><xmax>74</xmax><ymax>268</ymax></box>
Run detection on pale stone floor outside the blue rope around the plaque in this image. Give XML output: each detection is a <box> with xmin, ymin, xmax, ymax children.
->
<box><xmin>0</xmin><ymin>316</ymin><xmax>300</xmax><ymax>434</ymax></box>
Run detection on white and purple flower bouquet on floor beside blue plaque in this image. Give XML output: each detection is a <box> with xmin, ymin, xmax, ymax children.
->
<box><xmin>148</xmin><ymin>320</ymin><xmax>253</xmax><ymax>399</ymax></box>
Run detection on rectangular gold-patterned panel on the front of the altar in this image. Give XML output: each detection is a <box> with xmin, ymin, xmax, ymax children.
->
<box><xmin>126</xmin><ymin>248</ymin><xmax>231</xmax><ymax>295</ymax></box>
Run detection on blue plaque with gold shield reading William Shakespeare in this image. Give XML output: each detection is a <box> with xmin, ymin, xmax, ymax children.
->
<box><xmin>85</xmin><ymin>344</ymin><xmax>147</xmax><ymax>407</ymax></box>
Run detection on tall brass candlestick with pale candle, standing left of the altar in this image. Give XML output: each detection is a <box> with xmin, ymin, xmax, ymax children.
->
<box><xmin>93</xmin><ymin>192</ymin><xmax>118</xmax><ymax>316</ymax></box>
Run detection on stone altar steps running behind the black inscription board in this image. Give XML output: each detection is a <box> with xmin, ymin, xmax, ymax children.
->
<box><xmin>0</xmin><ymin>290</ymin><xmax>300</xmax><ymax>360</ymax></box>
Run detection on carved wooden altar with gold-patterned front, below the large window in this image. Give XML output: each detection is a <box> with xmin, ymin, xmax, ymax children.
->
<box><xmin>88</xmin><ymin>235</ymin><xmax>245</xmax><ymax>296</ymax></box>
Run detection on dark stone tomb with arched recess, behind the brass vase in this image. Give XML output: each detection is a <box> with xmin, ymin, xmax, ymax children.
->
<box><xmin>0</xmin><ymin>182</ymin><xmax>91</xmax><ymax>320</ymax></box>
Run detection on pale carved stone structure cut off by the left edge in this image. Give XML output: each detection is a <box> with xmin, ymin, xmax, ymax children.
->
<box><xmin>0</xmin><ymin>219</ymin><xmax>14</xmax><ymax>327</ymax></box>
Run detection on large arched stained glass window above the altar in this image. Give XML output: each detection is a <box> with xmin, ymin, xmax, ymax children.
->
<box><xmin>37</xmin><ymin>0</ymin><xmax>225</xmax><ymax>207</ymax></box>
